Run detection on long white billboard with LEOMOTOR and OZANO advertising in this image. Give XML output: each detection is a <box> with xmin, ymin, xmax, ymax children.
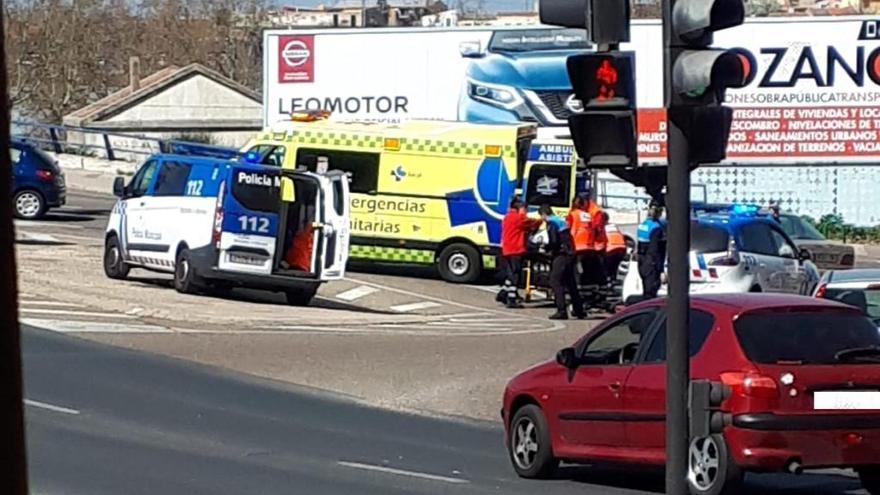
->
<box><xmin>263</xmin><ymin>17</ymin><xmax>880</xmax><ymax>164</ymax></box>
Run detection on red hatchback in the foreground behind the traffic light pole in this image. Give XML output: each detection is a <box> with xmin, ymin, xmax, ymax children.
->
<box><xmin>501</xmin><ymin>294</ymin><xmax>880</xmax><ymax>495</ymax></box>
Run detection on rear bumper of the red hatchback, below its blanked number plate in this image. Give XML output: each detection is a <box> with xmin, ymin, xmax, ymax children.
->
<box><xmin>724</xmin><ymin>414</ymin><xmax>880</xmax><ymax>471</ymax></box>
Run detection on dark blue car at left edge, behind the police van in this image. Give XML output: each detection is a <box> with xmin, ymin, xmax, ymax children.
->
<box><xmin>9</xmin><ymin>139</ymin><xmax>67</xmax><ymax>220</ymax></box>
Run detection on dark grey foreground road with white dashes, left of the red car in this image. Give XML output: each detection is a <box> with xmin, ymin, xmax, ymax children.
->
<box><xmin>23</xmin><ymin>328</ymin><xmax>861</xmax><ymax>495</ymax></box>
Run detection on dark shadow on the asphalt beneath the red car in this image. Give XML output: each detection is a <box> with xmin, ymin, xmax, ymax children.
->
<box><xmin>557</xmin><ymin>466</ymin><xmax>864</xmax><ymax>495</ymax></box>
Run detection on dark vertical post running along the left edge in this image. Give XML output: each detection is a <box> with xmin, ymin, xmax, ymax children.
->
<box><xmin>0</xmin><ymin>1</ymin><xmax>28</xmax><ymax>495</ymax></box>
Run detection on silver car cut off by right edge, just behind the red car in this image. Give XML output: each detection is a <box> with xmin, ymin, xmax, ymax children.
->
<box><xmin>814</xmin><ymin>268</ymin><xmax>880</xmax><ymax>326</ymax></box>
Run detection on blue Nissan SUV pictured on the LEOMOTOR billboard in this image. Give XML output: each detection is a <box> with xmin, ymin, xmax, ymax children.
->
<box><xmin>458</xmin><ymin>28</ymin><xmax>590</xmax><ymax>127</ymax></box>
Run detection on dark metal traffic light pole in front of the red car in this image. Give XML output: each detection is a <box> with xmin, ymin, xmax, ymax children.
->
<box><xmin>662</xmin><ymin>0</ymin><xmax>691</xmax><ymax>495</ymax></box>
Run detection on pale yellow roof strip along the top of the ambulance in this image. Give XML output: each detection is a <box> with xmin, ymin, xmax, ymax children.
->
<box><xmin>265</xmin><ymin>120</ymin><xmax>536</xmax><ymax>145</ymax></box>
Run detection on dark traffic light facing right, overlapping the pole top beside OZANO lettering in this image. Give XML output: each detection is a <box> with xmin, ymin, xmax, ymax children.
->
<box><xmin>664</xmin><ymin>0</ymin><xmax>754</xmax><ymax>168</ymax></box>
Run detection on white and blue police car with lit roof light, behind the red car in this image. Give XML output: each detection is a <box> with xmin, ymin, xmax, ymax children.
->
<box><xmin>623</xmin><ymin>205</ymin><xmax>819</xmax><ymax>302</ymax></box>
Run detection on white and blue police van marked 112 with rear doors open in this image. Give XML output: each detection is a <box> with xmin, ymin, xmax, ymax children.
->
<box><xmin>104</xmin><ymin>154</ymin><xmax>349</xmax><ymax>304</ymax></box>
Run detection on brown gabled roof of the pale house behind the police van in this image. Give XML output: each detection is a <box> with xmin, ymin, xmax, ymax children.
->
<box><xmin>64</xmin><ymin>64</ymin><xmax>263</xmax><ymax>126</ymax></box>
